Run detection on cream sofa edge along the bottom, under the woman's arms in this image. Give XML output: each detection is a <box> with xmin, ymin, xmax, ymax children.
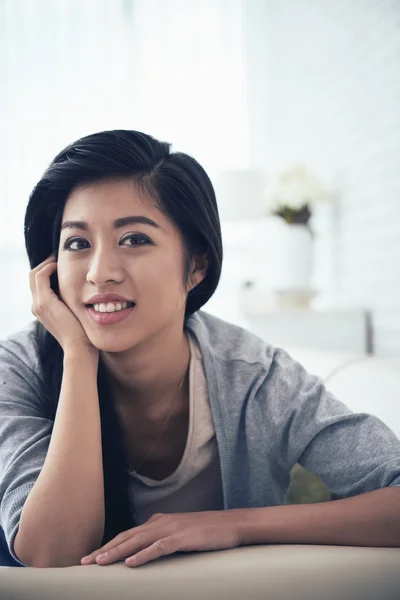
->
<box><xmin>0</xmin><ymin>545</ymin><xmax>400</xmax><ymax>600</ymax></box>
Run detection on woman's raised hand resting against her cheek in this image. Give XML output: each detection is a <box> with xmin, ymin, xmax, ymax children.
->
<box><xmin>29</xmin><ymin>255</ymin><xmax>96</xmax><ymax>352</ymax></box>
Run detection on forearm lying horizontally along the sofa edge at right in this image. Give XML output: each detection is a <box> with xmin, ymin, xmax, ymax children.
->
<box><xmin>242</xmin><ymin>488</ymin><xmax>400</xmax><ymax>548</ymax></box>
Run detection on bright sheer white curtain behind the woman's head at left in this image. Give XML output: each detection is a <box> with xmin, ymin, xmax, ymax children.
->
<box><xmin>0</xmin><ymin>0</ymin><xmax>249</xmax><ymax>338</ymax></box>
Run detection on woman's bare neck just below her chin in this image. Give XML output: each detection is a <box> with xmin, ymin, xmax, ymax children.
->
<box><xmin>102</xmin><ymin>324</ymin><xmax>190</xmax><ymax>418</ymax></box>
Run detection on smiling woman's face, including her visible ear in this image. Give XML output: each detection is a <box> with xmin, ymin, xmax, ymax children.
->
<box><xmin>57</xmin><ymin>180</ymin><xmax>205</xmax><ymax>352</ymax></box>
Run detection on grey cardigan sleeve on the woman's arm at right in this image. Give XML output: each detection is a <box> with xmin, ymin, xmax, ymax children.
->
<box><xmin>266</xmin><ymin>349</ymin><xmax>400</xmax><ymax>497</ymax></box>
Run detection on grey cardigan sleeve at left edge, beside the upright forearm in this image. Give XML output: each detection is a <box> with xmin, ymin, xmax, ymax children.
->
<box><xmin>0</xmin><ymin>332</ymin><xmax>53</xmax><ymax>564</ymax></box>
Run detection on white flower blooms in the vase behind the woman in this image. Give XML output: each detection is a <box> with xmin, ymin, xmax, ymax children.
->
<box><xmin>267</xmin><ymin>164</ymin><xmax>330</xmax><ymax>211</ymax></box>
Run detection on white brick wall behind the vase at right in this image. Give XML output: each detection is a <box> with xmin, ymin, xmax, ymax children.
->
<box><xmin>242</xmin><ymin>0</ymin><xmax>400</xmax><ymax>355</ymax></box>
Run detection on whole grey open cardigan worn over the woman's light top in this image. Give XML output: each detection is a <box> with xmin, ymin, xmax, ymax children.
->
<box><xmin>0</xmin><ymin>311</ymin><xmax>400</xmax><ymax>560</ymax></box>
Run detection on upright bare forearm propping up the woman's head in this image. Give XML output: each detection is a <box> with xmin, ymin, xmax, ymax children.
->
<box><xmin>14</xmin><ymin>350</ymin><xmax>105</xmax><ymax>566</ymax></box>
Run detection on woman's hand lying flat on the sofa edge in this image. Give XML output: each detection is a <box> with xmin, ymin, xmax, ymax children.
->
<box><xmin>81</xmin><ymin>509</ymin><xmax>247</xmax><ymax>567</ymax></box>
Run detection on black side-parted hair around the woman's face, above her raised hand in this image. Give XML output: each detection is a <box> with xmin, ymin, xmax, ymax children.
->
<box><xmin>25</xmin><ymin>130</ymin><xmax>222</xmax><ymax>317</ymax></box>
